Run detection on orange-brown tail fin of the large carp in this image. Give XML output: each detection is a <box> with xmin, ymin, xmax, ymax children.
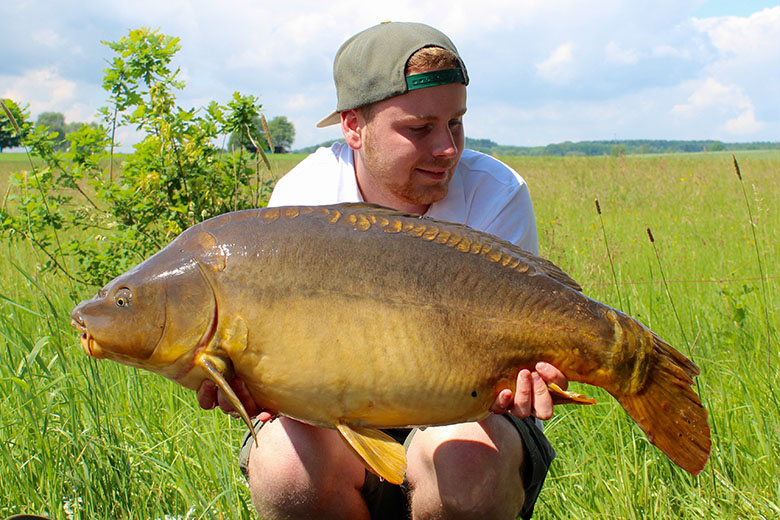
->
<box><xmin>614</xmin><ymin>335</ymin><xmax>712</xmax><ymax>475</ymax></box>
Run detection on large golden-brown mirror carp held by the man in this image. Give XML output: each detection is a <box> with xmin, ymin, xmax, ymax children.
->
<box><xmin>71</xmin><ymin>203</ymin><xmax>711</xmax><ymax>483</ymax></box>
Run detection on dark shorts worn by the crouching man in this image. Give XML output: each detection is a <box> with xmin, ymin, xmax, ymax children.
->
<box><xmin>238</xmin><ymin>414</ymin><xmax>555</xmax><ymax>520</ymax></box>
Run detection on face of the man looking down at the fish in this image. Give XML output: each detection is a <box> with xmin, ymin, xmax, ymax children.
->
<box><xmin>357</xmin><ymin>83</ymin><xmax>466</xmax><ymax>213</ymax></box>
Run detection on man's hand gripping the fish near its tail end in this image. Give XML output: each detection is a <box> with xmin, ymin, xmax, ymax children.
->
<box><xmin>490</xmin><ymin>362</ymin><xmax>569</xmax><ymax>420</ymax></box>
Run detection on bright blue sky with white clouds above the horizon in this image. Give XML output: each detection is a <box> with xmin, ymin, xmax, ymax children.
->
<box><xmin>0</xmin><ymin>0</ymin><xmax>780</xmax><ymax>148</ymax></box>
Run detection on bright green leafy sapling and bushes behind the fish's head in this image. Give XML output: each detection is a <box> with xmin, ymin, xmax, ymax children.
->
<box><xmin>0</xmin><ymin>29</ymin><xmax>272</xmax><ymax>286</ymax></box>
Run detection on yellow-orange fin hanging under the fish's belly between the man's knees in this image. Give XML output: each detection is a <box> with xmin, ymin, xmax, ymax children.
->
<box><xmin>336</xmin><ymin>423</ymin><xmax>406</xmax><ymax>484</ymax></box>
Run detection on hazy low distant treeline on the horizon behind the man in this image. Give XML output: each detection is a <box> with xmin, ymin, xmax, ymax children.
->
<box><xmin>295</xmin><ymin>137</ymin><xmax>780</xmax><ymax>156</ymax></box>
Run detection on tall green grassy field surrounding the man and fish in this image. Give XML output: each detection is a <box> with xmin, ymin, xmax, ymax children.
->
<box><xmin>0</xmin><ymin>152</ymin><xmax>780</xmax><ymax>520</ymax></box>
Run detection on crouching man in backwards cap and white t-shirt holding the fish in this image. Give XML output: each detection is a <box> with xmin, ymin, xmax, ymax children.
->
<box><xmin>198</xmin><ymin>23</ymin><xmax>567</xmax><ymax>520</ymax></box>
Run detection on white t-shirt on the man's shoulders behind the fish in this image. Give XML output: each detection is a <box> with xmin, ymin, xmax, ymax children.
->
<box><xmin>268</xmin><ymin>143</ymin><xmax>539</xmax><ymax>255</ymax></box>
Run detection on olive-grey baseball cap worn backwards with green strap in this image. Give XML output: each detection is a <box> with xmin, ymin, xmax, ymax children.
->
<box><xmin>317</xmin><ymin>22</ymin><xmax>469</xmax><ymax>128</ymax></box>
